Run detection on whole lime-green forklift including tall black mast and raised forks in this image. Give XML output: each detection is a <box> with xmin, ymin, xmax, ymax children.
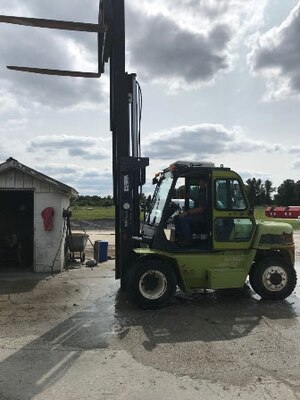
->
<box><xmin>0</xmin><ymin>0</ymin><xmax>297</xmax><ymax>309</ymax></box>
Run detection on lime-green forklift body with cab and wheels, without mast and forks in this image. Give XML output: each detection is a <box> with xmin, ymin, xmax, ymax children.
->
<box><xmin>126</xmin><ymin>161</ymin><xmax>297</xmax><ymax>308</ymax></box>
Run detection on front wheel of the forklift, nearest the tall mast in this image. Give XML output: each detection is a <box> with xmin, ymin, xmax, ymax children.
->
<box><xmin>127</xmin><ymin>258</ymin><xmax>177</xmax><ymax>309</ymax></box>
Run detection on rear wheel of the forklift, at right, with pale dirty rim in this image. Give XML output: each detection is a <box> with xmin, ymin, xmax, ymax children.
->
<box><xmin>249</xmin><ymin>257</ymin><xmax>297</xmax><ymax>300</ymax></box>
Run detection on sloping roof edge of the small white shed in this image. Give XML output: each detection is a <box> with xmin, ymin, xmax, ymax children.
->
<box><xmin>0</xmin><ymin>157</ymin><xmax>78</xmax><ymax>198</ymax></box>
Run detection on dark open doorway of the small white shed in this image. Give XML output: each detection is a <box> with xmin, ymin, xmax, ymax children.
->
<box><xmin>0</xmin><ymin>190</ymin><xmax>33</xmax><ymax>270</ymax></box>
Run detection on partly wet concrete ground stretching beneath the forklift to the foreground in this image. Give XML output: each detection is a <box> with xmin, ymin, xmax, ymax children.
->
<box><xmin>0</xmin><ymin>232</ymin><xmax>300</xmax><ymax>400</ymax></box>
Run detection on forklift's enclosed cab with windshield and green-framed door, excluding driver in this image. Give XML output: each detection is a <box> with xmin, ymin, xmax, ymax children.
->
<box><xmin>142</xmin><ymin>161</ymin><xmax>255</xmax><ymax>252</ymax></box>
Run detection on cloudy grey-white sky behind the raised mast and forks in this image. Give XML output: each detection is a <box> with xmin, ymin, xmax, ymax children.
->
<box><xmin>0</xmin><ymin>0</ymin><xmax>300</xmax><ymax>195</ymax></box>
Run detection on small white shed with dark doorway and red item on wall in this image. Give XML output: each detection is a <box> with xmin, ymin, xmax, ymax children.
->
<box><xmin>0</xmin><ymin>158</ymin><xmax>78</xmax><ymax>272</ymax></box>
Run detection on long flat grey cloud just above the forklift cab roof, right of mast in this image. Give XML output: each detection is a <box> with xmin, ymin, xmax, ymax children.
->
<box><xmin>143</xmin><ymin>124</ymin><xmax>282</xmax><ymax>160</ymax></box>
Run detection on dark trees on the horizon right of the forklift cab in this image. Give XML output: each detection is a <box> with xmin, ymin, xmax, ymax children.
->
<box><xmin>245</xmin><ymin>178</ymin><xmax>300</xmax><ymax>206</ymax></box>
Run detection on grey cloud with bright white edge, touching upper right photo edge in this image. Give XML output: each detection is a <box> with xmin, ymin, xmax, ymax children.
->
<box><xmin>249</xmin><ymin>3</ymin><xmax>300</xmax><ymax>100</ymax></box>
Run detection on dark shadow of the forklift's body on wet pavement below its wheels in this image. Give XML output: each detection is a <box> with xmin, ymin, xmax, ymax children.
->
<box><xmin>115</xmin><ymin>287</ymin><xmax>300</xmax><ymax>350</ymax></box>
